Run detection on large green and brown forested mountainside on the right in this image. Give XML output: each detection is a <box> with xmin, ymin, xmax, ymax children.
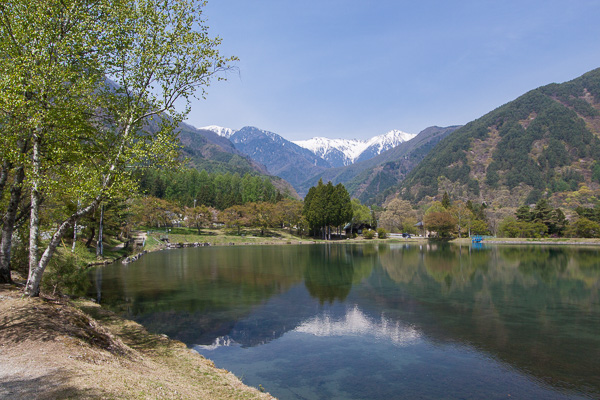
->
<box><xmin>400</xmin><ymin>69</ymin><xmax>600</xmax><ymax>206</ymax></box>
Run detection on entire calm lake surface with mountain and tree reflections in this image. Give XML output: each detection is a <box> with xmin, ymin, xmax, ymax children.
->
<box><xmin>90</xmin><ymin>243</ymin><xmax>600</xmax><ymax>399</ymax></box>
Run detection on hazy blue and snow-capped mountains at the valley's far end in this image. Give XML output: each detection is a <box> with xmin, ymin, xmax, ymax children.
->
<box><xmin>200</xmin><ymin>125</ymin><xmax>457</xmax><ymax>197</ymax></box>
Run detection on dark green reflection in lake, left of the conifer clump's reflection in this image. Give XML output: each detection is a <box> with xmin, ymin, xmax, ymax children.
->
<box><xmin>92</xmin><ymin>246</ymin><xmax>308</xmax><ymax>344</ymax></box>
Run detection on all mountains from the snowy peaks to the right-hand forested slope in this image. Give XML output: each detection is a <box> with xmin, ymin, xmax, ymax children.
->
<box><xmin>191</xmin><ymin>69</ymin><xmax>600</xmax><ymax>208</ymax></box>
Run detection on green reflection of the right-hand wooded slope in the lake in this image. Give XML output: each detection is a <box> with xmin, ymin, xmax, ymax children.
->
<box><xmin>376</xmin><ymin>246</ymin><xmax>600</xmax><ymax>393</ymax></box>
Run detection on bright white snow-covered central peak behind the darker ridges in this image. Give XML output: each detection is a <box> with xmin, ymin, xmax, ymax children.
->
<box><xmin>293</xmin><ymin>130</ymin><xmax>416</xmax><ymax>167</ymax></box>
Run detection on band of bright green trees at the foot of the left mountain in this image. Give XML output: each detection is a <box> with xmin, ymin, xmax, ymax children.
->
<box><xmin>139</xmin><ymin>168</ymin><xmax>283</xmax><ymax>210</ymax></box>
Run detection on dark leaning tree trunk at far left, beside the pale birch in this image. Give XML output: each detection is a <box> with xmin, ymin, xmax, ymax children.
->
<box><xmin>0</xmin><ymin>166</ymin><xmax>25</xmax><ymax>283</ymax></box>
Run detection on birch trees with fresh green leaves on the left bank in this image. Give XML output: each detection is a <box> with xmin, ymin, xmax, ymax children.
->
<box><xmin>0</xmin><ymin>0</ymin><xmax>234</xmax><ymax>296</ymax></box>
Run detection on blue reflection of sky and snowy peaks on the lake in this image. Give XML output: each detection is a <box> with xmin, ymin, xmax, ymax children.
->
<box><xmin>194</xmin><ymin>305</ymin><xmax>585</xmax><ymax>400</ymax></box>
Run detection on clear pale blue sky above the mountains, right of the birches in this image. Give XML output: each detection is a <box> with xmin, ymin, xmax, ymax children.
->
<box><xmin>188</xmin><ymin>0</ymin><xmax>600</xmax><ymax>140</ymax></box>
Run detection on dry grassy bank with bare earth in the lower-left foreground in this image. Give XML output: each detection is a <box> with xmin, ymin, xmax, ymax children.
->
<box><xmin>0</xmin><ymin>285</ymin><xmax>273</xmax><ymax>399</ymax></box>
